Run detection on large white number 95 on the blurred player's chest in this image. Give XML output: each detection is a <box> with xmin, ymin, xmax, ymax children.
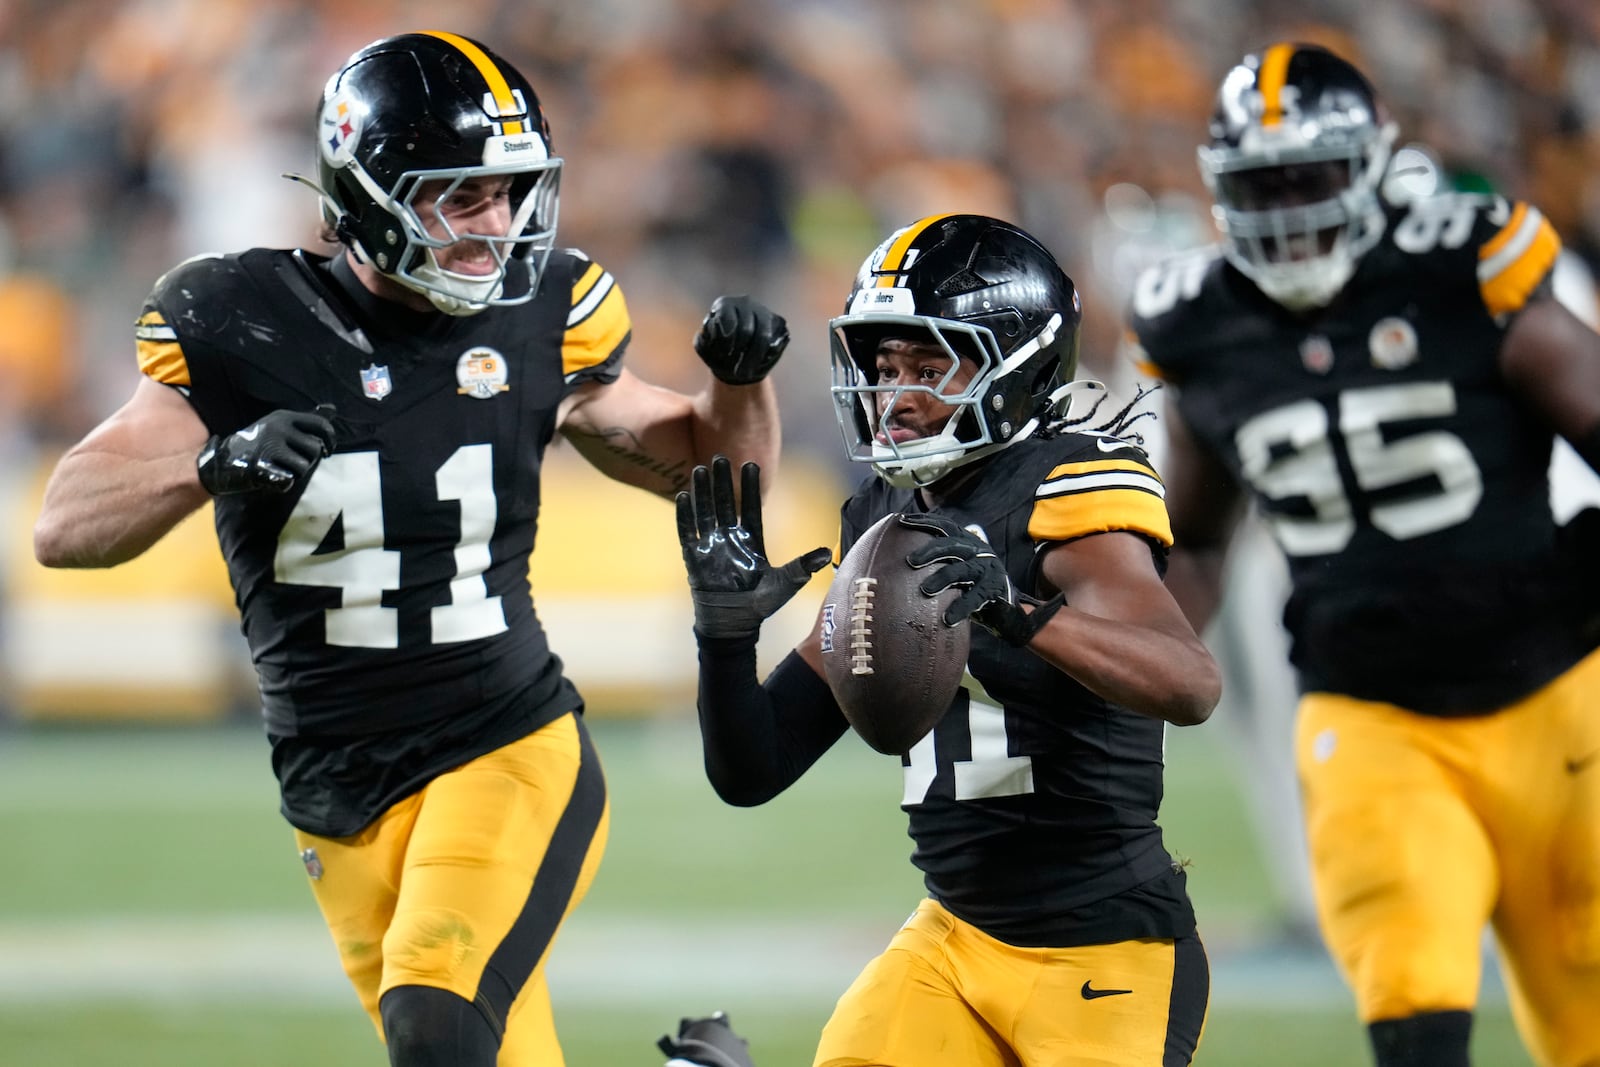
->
<box><xmin>1234</xmin><ymin>382</ymin><xmax>1483</xmax><ymax>555</ymax></box>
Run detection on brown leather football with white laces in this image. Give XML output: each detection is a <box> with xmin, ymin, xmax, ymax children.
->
<box><xmin>821</xmin><ymin>512</ymin><xmax>971</xmax><ymax>755</ymax></box>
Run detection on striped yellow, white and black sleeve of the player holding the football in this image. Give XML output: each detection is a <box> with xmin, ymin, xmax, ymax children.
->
<box><xmin>1027</xmin><ymin>437</ymin><xmax>1173</xmax><ymax>549</ymax></box>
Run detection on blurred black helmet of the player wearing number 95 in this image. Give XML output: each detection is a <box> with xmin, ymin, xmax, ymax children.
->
<box><xmin>1198</xmin><ymin>43</ymin><xmax>1395</xmax><ymax>310</ymax></box>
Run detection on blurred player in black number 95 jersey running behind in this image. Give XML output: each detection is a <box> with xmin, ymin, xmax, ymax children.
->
<box><xmin>1131</xmin><ymin>43</ymin><xmax>1600</xmax><ymax>1067</ymax></box>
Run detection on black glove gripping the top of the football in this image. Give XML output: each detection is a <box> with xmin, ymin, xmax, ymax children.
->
<box><xmin>899</xmin><ymin>515</ymin><xmax>1066</xmax><ymax>648</ymax></box>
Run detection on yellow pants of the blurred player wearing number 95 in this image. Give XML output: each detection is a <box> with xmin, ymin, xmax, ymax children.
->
<box><xmin>1296</xmin><ymin>653</ymin><xmax>1600</xmax><ymax>1067</ymax></box>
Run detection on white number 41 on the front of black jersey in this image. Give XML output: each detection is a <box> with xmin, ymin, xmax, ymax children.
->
<box><xmin>274</xmin><ymin>445</ymin><xmax>506</xmax><ymax>648</ymax></box>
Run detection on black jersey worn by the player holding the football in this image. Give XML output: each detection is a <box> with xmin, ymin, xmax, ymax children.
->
<box><xmin>840</xmin><ymin>434</ymin><xmax>1194</xmax><ymax>945</ymax></box>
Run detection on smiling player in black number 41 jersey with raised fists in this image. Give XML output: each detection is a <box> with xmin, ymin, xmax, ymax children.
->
<box><xmin>35</xmin><ymin>32</ymin><xmax>789</xmax><ymax>1067</ymax></box>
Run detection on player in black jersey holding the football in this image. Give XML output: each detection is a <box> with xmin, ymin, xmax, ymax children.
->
<box><xmin>677</xmin><ymin>214</ymin><xmax>1221</xmax><ymax>1067</ymax></box>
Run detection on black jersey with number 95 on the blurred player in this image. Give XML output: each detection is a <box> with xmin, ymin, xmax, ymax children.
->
<box><xmin>1131</xmin><ymin>195</ymin><xmax>1587</xmax><ymax>713</ymax></box>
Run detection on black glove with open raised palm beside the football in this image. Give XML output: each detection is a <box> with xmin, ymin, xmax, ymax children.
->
<box><xmin>678</xmin><ymin>456</ymin><xmax>834</xmax><ymax>637</ymax></box>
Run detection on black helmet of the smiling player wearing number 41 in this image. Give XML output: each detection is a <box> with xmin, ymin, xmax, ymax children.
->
<box><xmin>305</xmin><ymin>30</ymin><xmax>562</xmax><ymax>315</ymax></box>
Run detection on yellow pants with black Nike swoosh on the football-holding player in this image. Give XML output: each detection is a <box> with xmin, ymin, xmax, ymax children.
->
<box><xmin>813</xmin><ymin>901</ymin><xmax>1210</xmax><ymax>1067</ymax></box>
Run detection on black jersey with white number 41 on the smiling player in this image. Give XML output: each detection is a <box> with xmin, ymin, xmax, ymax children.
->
<box><xmin>138</xmin><ymin>250</ymin><xmax>629</xmax><ymax>833</ymax></box>
